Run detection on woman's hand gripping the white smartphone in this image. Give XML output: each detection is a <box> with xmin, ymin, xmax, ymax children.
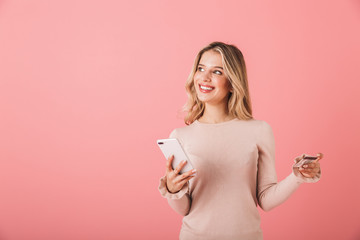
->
<box><xmin>166</xmin><ymin>155</ymin><xmax>196</xmax><ymax>193</ymax></box>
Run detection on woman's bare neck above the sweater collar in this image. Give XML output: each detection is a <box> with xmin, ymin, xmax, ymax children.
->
<box><xmin>198</xmin><ymin>103</ymin><xmax>234</xmax><ymax>123</ymax></box>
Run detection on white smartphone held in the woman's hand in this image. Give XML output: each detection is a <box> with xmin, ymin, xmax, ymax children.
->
<box><xmin>157</xmin><ymin>138</ymin><xmax>193</xmax><ymax>174</ymax></box>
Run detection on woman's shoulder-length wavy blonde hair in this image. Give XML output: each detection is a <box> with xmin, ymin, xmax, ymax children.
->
<box><xmin>182</xmin><ymin>42</ymin><xmax>253</xmax><ymax>125</ymax></box>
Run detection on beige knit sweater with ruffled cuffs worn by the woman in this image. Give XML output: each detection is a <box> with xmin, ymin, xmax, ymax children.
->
<box><xmin>159</xmin><ymin>119</ymin><xmax>320</xmax><ymax>240</ymax></box>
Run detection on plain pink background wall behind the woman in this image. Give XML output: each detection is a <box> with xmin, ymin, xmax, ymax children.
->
<box><xmin>0</xmin><ymin>0</ymin><xmax>360</xmax><ymax>240</ymax></box>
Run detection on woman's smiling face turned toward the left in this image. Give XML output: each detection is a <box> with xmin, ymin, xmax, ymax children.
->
<box><xmin>194</xmin><ymin>50</ymin><xmax>231</xmax><ymax>105</ymax></box>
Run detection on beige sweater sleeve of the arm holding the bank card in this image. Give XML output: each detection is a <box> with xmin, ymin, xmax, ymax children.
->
<box><xmin>257</xmin><ymin>121</ymin><xmax>320</xmax><ymax>211</ymax></box>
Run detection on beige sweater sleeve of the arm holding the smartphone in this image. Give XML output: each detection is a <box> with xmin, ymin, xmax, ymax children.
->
<box><xmin>158</xmin><ymin>129</ymin><xmax>191</xmax><ymax>216</ymax></box>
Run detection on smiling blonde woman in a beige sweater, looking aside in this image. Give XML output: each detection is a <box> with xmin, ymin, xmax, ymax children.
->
<box><xmin>159</xmin><ymin>42</ymin><xmax>321</xmax><ymax>240</ymax></box>
